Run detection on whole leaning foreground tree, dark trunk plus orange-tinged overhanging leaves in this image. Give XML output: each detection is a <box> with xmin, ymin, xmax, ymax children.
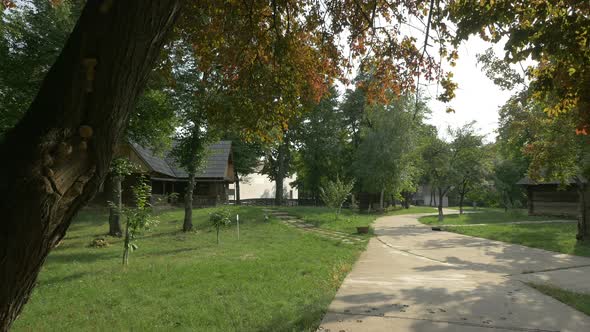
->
<box><xmin>0</xmin><ymin>0</ymin><xmax>453</xmax><ymax>329</ymax></box>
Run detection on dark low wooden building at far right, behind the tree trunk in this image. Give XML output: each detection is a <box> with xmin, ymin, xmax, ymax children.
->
<box><xmin>517</xmin><ymin>177</ymin><xmax>590</xmax><ymax>217</ymax></box>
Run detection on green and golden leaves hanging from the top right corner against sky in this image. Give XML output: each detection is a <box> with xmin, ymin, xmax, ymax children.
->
<box><xmin>444</xmin><ymin>0</ymin><xmax>590</xmax><ymax>133</ymax></box>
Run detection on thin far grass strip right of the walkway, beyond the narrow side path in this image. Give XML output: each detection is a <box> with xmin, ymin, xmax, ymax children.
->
<box><xmin>419</xmin><ymin>209</ymin><xmax>564</xmax><ymax>225</ymax></box>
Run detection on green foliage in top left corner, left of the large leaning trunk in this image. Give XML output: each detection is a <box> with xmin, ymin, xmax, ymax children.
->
<box><xmin>0</xmin><ymin>0</ymin><xmax>81</xmax><ymax>137</ymax></box>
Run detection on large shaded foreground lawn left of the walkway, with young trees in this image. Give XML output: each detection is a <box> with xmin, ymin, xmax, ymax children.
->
<box><xmin>13</xmin><ymin>207</ymin><xmax>366</xmax><ymax>331</ymax></box>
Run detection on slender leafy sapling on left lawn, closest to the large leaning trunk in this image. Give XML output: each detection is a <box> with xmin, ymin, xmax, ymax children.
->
<box><xmin>121</xmin><ymin>179</ymin><xmax>158</xmax><ymax>265</ymax></box>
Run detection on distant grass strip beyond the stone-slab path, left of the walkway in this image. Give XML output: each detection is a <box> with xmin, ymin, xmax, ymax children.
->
<box><xmin>279</xmin><ymin>206</ymin><xmax>436</xmax><ymax>233</ymax></box>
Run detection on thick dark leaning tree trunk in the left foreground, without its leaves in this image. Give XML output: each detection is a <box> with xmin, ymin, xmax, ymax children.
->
<box><xmin>0</xmin><ymin>0</ymin><xmax>180</xmax><ymax>331</ymax></box>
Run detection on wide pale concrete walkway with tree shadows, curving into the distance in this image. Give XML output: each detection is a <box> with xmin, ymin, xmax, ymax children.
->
<box><xmin>319</xmin><ymin>215</ymin><xmax>590</xmax><ymax>332</ymax></box>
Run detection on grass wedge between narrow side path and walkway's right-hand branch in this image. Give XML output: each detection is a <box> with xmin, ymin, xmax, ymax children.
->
<box><xmin>445</xmin><ymin>223</ymin><xmax>590</xmax><ymax>257</ymax></box>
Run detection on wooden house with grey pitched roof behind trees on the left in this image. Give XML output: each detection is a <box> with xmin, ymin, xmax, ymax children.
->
<box><xmin>96</xmin><ymin>141</ymin><xmax>234</xmax><ymax>206</ymax></box>
